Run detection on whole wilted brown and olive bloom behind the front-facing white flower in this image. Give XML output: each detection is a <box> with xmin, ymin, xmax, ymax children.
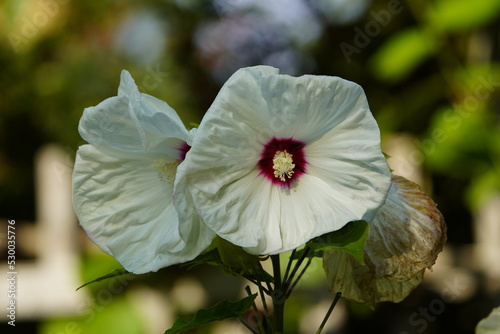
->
<box><xmin>323</xmin><ymin>175</ymin><xmax>446</xmax><ymax>307</ymax></box>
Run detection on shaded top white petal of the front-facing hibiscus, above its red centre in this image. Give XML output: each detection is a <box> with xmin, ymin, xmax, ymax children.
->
<box><xmin>207</xmin><ymin>66</ymin><xmax>380</xmax><ymax>146</ymax></box>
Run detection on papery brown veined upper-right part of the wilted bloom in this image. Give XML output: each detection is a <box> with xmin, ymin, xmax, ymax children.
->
<box><xmin>365</xmin><ymin>175</ymin><xmax>446</xmax><ymax>281</ymax></box>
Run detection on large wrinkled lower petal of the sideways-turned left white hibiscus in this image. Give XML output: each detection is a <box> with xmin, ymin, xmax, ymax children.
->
<box><xmin>73</xmin><ymin>145</ymin><xmax>211</xmax><ymax>274</ymax></box>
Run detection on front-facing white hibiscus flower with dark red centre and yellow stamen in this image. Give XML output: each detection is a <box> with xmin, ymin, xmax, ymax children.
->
<box><xmin>179</xmin><ymin>66</ymin><xmax>391</xmax><ymax>254</ymax></box>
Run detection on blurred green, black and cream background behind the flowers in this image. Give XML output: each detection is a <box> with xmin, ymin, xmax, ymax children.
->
<box><xmin>0</xmin><ymin>0</ymin><xmax>500</xmax><ymax>334</ymax></box>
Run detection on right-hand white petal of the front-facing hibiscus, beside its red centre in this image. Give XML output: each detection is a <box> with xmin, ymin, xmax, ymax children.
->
<box><xmin>306</xmin><ymin>105</ymin><xmax>391</xmax><ymax>221</ymax></box>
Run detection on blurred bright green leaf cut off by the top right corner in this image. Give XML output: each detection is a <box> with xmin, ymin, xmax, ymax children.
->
<box><xmin>427</xmin><ymin>0</ymin><xmax>500</xmax><ymax>32</ymax></box>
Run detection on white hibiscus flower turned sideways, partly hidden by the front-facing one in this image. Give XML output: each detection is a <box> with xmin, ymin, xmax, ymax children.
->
<box><xmin>73</xmin><ymin>71</ymin><xmax>214</xmax><ymax>274</ymax></box>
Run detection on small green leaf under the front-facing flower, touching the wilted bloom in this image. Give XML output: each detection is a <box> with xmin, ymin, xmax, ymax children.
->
<box><xmin>308</xmin><ymin>220</ymin><xmax>369</xmax><ymax>265</ymax></box>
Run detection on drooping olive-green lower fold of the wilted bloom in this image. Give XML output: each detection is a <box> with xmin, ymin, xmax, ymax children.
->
<box><xmin>323</xmin><ymin>251</ymin><xmax>424</xmax><ymax>308</ymax></box>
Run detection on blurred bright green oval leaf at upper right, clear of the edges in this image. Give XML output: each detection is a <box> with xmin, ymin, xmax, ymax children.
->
<box><xmin>371</xmin><ymin>28</ymin><xmax>436</xmax><ymax>82</ymax></box>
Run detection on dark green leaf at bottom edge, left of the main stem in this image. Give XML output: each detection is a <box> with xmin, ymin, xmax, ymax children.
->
<box><xmin>165</xmin><ymin>294</ymin><xmax>257</xmax><ymax>334</ymax></box>
